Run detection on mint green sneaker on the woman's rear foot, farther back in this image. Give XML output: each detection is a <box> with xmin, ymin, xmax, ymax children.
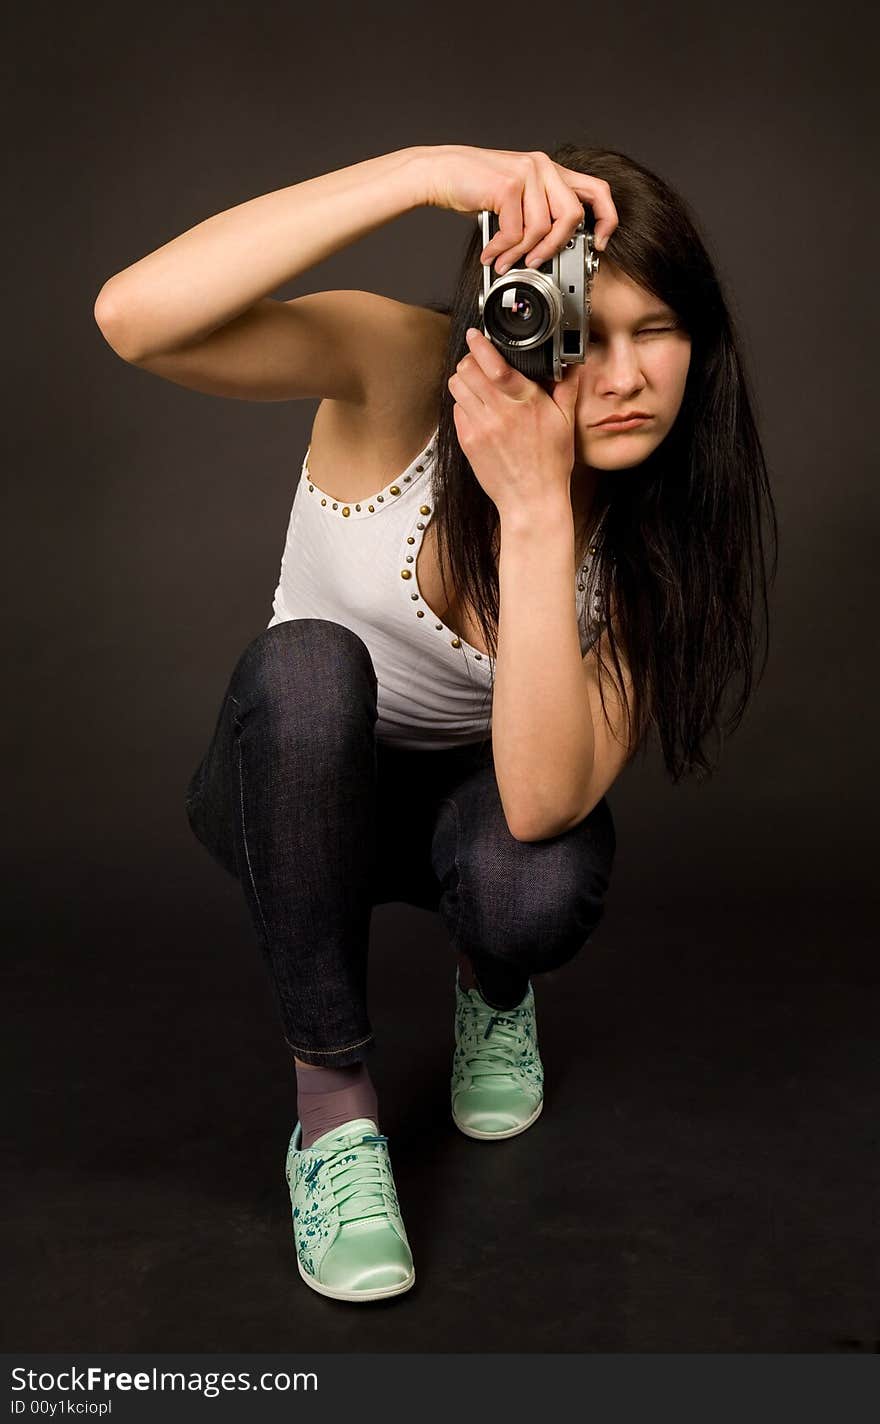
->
<box><xmin>451</xmin><ymin>971</ymin><xmax>544</xmax><ymax>1138</ymax></box>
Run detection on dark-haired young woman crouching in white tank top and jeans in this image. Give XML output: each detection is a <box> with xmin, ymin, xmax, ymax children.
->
<box><xmin>95</xmin><ymin>145</ymin><xmax>776</xmax><ymax>1302</ymax></box>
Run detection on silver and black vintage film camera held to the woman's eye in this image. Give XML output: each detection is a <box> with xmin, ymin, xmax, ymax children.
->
<box><xmin>477</xmin><ymin>209</ymin><xmax>599</xmax><ymax>382</ymax></box>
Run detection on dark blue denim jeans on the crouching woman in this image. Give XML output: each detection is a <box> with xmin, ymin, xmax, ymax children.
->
<box><xmin>187</xmin><ymin>618</ymin><xmax>615</xmax><ymax>1067</ymax></box>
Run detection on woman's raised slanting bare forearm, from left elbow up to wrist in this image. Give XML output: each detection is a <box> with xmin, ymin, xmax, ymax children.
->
<box><xmin>95</xmin><ymin>148</ymin><xmax>423</xmax><ymax>357</ymax></box>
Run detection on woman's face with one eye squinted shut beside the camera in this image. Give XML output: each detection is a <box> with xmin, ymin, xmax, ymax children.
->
<box><xmin>575</xmin><ymin>256</ymin><xmax>691</xmax><ymax>473</ymax></box>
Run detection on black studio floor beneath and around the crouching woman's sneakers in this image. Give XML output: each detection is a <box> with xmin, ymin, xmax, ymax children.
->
<box><xmin>3</xmin><ymin>860</ymin><xmax>880</xmax><ymax>1353</ymax></box>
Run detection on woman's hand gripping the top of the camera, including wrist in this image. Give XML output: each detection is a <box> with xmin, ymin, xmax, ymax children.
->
<box><xmin>421</xmin><ymin>144</ymin><xmax>618</xmax><ymax>273</ymax></box>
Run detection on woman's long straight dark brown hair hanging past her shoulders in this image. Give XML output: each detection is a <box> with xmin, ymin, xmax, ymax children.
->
<box><xmin>429</xmin><ymin>142</ymin><xmax>779</xmax><ymax>783</ymax></box>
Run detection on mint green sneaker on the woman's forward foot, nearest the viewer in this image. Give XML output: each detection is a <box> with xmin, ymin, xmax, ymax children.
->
<box><xmin>285</xmin><ymin>1118</ymin><xmax>416</xmax><ymax>1300</ymax></box>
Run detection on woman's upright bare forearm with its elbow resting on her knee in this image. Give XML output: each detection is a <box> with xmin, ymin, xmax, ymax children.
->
<box><xmin>493</xmin><ymin>504</ymin><xmax>594</xmax><ymax>840</ymax></box>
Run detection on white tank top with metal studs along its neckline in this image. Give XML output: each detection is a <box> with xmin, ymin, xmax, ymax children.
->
<box><xmin>268</xmin><ymin>429</ymin><xmax>599</xmax><ymax>750</ymax></box>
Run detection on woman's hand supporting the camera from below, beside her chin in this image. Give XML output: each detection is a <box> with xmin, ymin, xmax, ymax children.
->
<box><xmin>447</xmin><ymin>328</ymin><xmax>581</xmax><ymax>514</ymax></box>
